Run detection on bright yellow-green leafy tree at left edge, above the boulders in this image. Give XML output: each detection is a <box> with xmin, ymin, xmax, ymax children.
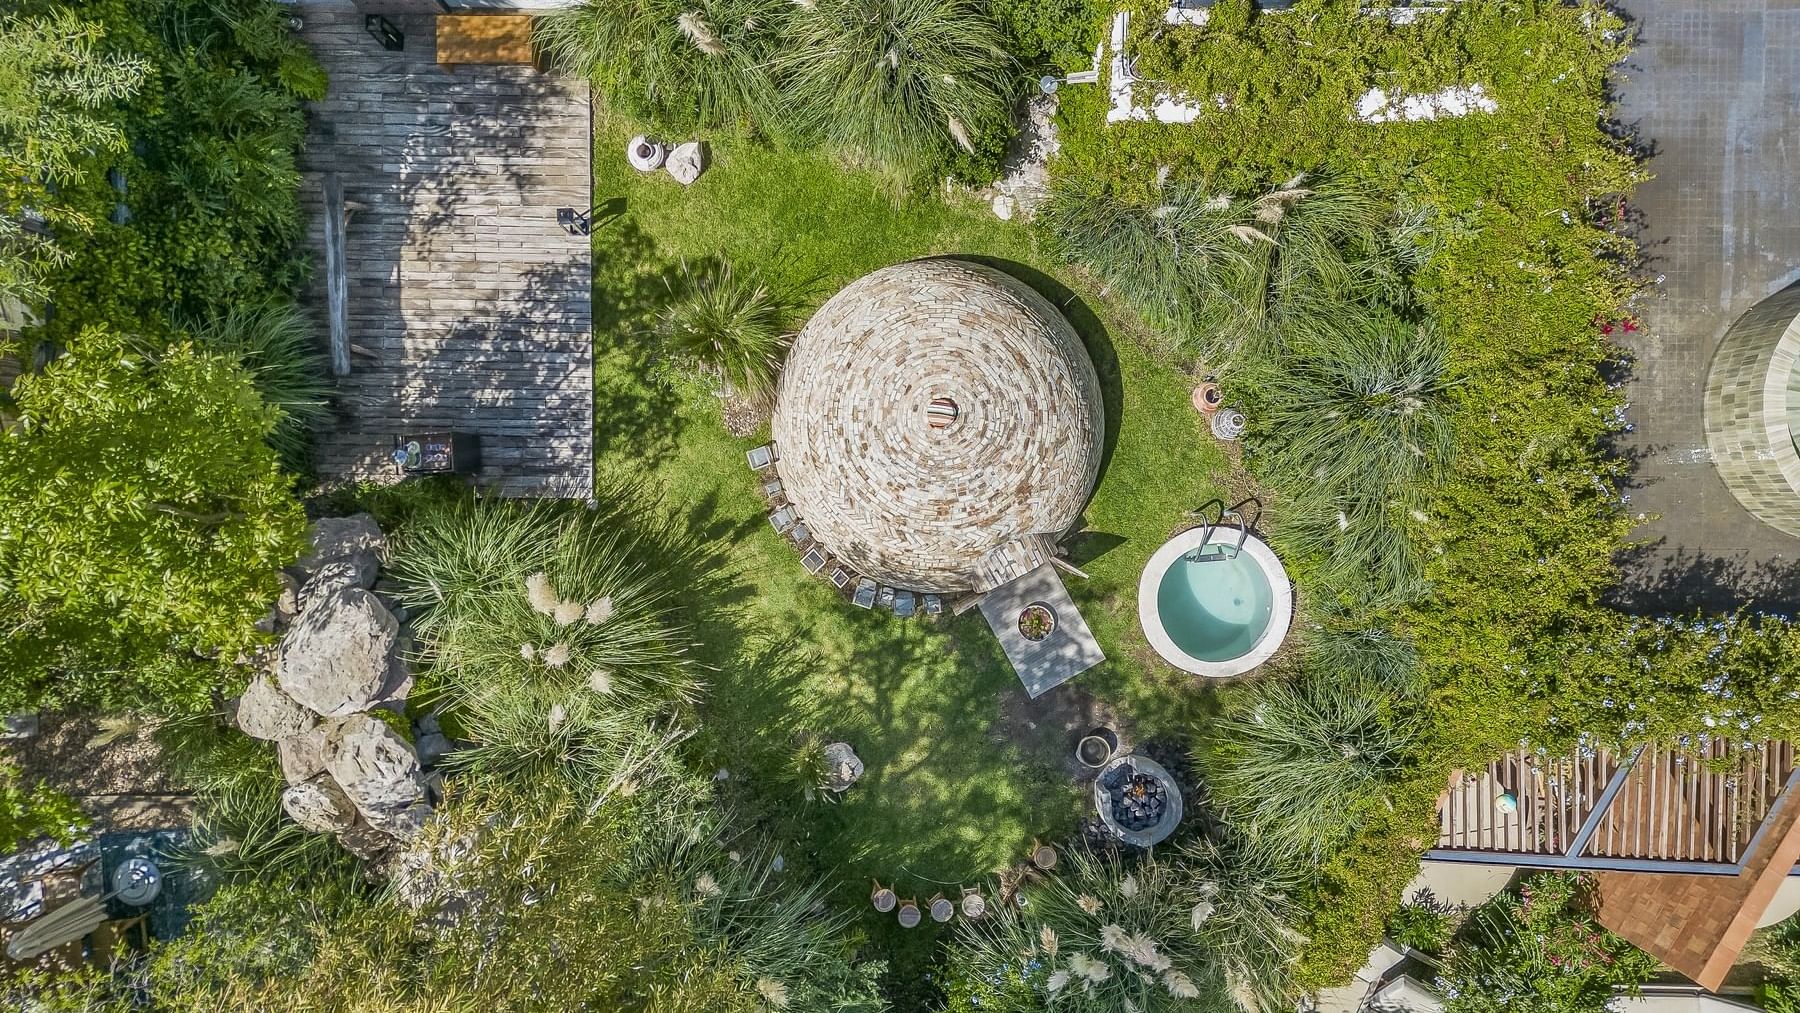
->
<box><xmin>0</xmin><ymin>329</ymin><xmax>306</xmax><ymax>709</ymax></box>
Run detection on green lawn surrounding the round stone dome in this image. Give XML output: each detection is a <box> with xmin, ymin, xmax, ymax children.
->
<box><xmin>594</xmin><ymin>117</ymin><xmax>1228</xmax><ymax>898</ymax></box>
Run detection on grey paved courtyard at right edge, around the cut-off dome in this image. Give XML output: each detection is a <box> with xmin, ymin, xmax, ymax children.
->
<box><xmin>1620</xmin><ymin>0</ymin><xmax>1800</xmax><ymax>610</ymax></box>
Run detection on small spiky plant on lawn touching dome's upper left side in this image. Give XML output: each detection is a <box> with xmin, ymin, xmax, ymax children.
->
<box><xmin>657</xmin><ymin>264</ymin><xmax>796</xmax><ymax>405</ymax></box>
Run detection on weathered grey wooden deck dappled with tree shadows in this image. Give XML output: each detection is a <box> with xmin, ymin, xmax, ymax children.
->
<box><xmin>302</xmin><ymin>4</ymin><xmax>594</xmax><ymax>497</ymax></box>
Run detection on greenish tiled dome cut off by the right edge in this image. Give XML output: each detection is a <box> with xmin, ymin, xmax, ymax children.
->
<box><xmin>1705</xmin><ymin>284</ymin><xmax>1800</xmax><ymax>536</ymax></box>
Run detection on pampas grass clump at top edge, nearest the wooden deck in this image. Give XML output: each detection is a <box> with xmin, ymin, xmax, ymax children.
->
<box><xmin>538</xmin><ymin>0</ymin><xmax>788</xmax><ymax>130</ymax></box>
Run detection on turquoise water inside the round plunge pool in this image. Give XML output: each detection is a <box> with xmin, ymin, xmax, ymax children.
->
<box><xmin>1156</xmin><ymin>549</ymin><xmax>1274</xmax><ymax>662</ymax></box>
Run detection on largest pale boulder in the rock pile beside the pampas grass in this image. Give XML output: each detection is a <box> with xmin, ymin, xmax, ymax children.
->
<box><xmin>275</xmin><ymin>587</ymin><xmax>407</xmax><ymax>718</ymax></box>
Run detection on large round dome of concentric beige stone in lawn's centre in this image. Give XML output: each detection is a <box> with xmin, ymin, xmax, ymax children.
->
<box><xmin>774</xmin><ymin>259</ymin><xmax>1105</xmax><ymax>594</ymax></box>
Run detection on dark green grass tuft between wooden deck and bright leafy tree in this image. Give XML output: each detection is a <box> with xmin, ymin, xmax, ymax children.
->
<box><xmin>193</xmin><ymin>302</ymin><xmax>331</xmax><ymax>473</ymax></box>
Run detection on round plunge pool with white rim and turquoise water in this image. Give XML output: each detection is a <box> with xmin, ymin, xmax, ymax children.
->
<box><xmin>1138</xmin><ymin>527</ymin><xmax>1294</xmax><ymax>678</ymax></box>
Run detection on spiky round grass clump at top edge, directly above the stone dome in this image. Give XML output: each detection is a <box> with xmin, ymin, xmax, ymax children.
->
<box><xmin>772</xmin><ymin>0</ymin><xmax>1015</xmax><ymax>180</ymax></box>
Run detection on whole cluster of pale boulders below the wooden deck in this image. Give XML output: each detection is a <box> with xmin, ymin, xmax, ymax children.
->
<box><xmin>236</xmin><ymin>515</ymin><xmax>435</xmax><ymax>864</ymax></box>
